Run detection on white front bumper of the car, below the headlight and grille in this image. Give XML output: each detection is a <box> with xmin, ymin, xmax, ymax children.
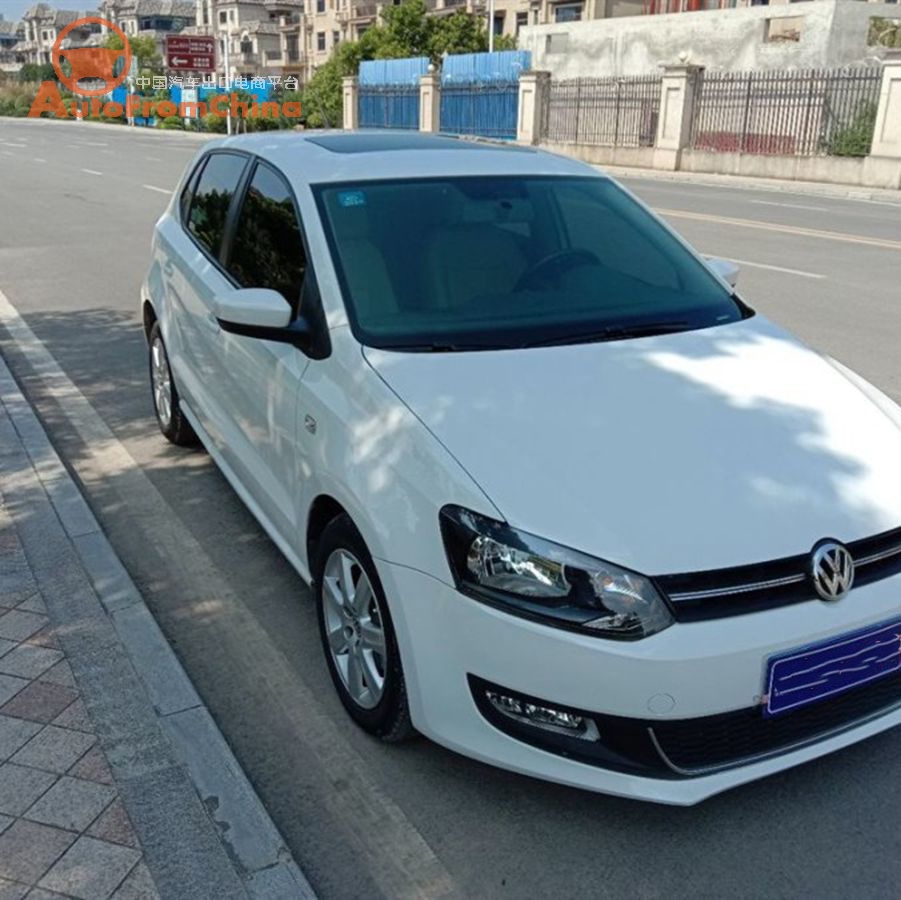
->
<box><xmin>378</xmin><ymin>562</ymin><xmax>901</xmax><ymax>804</ymax></box>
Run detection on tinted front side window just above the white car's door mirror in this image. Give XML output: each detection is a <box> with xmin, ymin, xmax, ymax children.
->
<box><xmin>228</xmin><ymin>164</ymin><xmax>306</xmax><ymax>304</ymax></box>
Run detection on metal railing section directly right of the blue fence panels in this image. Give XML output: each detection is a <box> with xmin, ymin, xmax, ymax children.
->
<box><xmin>542</xmin><ymin>75</ymin><xmax>661</xmax><ymax>147</ymax></box>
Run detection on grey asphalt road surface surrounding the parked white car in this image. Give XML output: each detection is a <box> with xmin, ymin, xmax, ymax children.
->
<box><xmin>0</xmin><ymin>119</ymin><xmax>901</xmax><ymax>900</ymax></box>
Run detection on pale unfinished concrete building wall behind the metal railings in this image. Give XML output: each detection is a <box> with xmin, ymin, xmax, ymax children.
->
<box><xmin>519</xmin><ymin>0</ymin><xmax>898</xmax><ymax>78</ymax></box>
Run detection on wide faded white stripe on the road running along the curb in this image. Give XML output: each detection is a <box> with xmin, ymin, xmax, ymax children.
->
<box><xmin>0</xmin><ymin>290</ymin><xmax>459</xmax><ymax>898</ymax></box>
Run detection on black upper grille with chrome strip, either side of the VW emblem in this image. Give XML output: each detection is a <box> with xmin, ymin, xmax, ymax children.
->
<box><xmin>654</xmin><ymin>528</ymin><xmax>901</xmax><ymax>622</ymax></box>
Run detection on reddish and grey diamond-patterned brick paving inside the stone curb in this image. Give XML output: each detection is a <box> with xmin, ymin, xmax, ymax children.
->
<box><xmin>0</xmin><ymin>501</ymin><xmax>159</xmax><ymax>900</ymax></box>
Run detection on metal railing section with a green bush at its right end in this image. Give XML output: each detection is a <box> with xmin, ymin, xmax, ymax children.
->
<box><xmin>691</xmin><ymin>66</ymin><xmax>882</xmax><ymax>156</ymax></box>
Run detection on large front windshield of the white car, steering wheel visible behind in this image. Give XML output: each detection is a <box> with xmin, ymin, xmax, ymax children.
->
<box><xmin>315</xmin><ymin>175</ymin><xmax>746</xmax><ymax>351</ymax></box>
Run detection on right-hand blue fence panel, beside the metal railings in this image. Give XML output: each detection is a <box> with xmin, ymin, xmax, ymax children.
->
<box><xmin>441</xmin><ymin>50</ymin><xmax>532</xmax><ymax>140</ymax></box>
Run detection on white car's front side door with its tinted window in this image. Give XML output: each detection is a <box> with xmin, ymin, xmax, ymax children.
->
<box><xmin>214</xmin><ymin>160</ymin><xmax>309</xmax><ymax>539</ymax></box>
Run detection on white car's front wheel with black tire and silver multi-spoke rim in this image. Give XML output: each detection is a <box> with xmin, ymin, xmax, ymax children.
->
<box><xmin>313</xmin><ymin>515</ymin><xmax>415</xmax><ymax>743</ymax></box>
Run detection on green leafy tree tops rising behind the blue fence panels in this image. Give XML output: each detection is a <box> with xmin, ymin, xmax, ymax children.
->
<box><xmin>303</xmin><ymin>0</ymin><xmax>516</xmax><ymax>128</ymax></box>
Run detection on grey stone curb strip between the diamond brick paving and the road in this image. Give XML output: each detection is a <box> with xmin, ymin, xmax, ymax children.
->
<box><xmin>0</xmin><ymin>344</ymin><xmax>315</xmax><ymax>900</ymax></box>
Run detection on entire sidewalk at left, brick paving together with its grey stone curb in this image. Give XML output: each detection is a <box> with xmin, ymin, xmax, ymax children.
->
<box><xmin>0</xmin><ymin>359</ymin><xmax>314</xmax><ymax>900</ymax></box>
